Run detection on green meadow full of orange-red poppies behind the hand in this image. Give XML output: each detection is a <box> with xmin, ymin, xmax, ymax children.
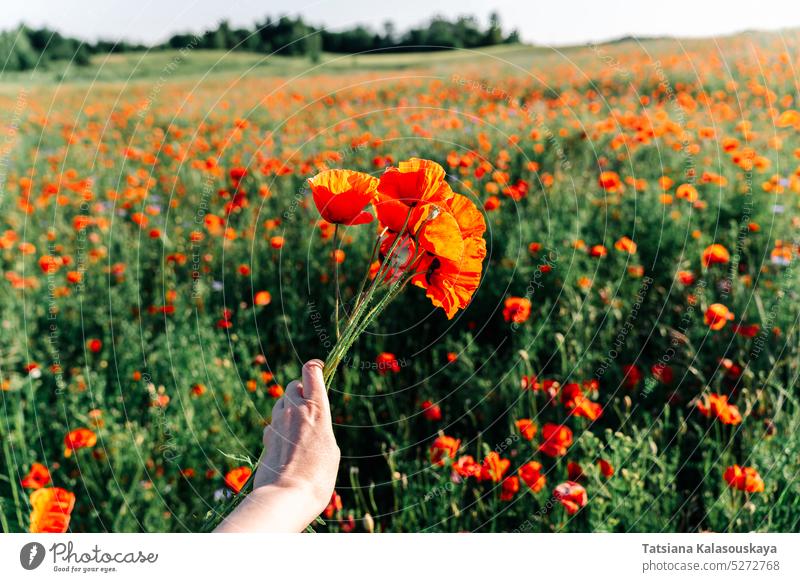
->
<box><xmin>0</xmin><ymin>33</ymin><xmax>800</xmax><ymax>532</ymax></box>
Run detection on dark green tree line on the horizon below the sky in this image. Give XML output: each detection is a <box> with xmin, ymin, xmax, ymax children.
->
<box><xmin>0</xmin><ymin>13</ymin><xmax>519</xmax><ymax>71</ymax></box>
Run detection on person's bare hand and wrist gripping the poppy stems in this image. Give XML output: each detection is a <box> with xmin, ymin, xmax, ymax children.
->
<box><xmin>215</xmin><ymin>360</ymin><xmax>340</xmax><ymax>532</ymax></box>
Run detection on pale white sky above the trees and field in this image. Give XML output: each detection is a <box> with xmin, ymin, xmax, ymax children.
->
<box><xmin>0</xmin><ymin>0</ymin><xmax>800</xmax><ymax>46</ymax></box>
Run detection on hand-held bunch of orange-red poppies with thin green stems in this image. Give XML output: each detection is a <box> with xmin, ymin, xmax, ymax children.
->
<box><xmin>309</xmin><ymin>158</ymin><xmax>486</xmax><ymax>385</ymax></box>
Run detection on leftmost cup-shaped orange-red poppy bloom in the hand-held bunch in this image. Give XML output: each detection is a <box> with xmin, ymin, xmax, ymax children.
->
<box><xmin>308</xmin><ymin>170</ymin><xmax>378</xmax><ymax>225</ymax></box>
